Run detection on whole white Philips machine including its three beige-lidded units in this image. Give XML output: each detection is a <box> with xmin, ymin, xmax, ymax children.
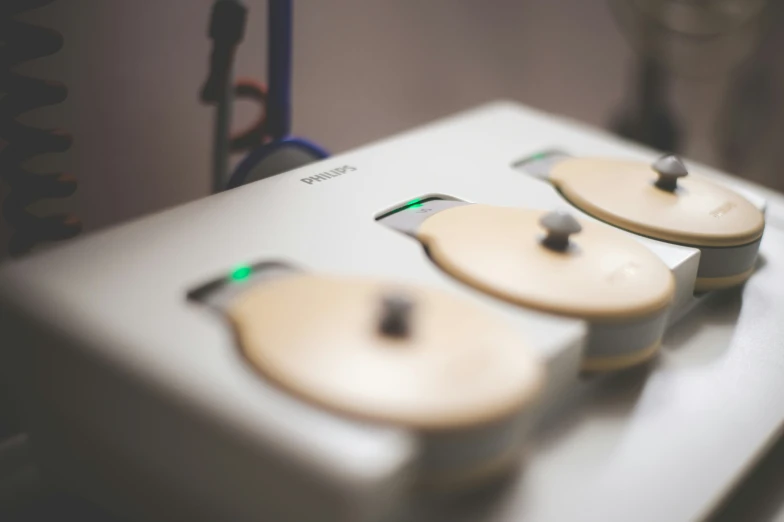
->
<box><xmin>0</xmin><ymin>102</ymin><xmax>784</xmax><ymax>522</ymax></box>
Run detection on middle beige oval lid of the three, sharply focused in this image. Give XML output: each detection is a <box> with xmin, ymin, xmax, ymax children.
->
<box><xmin>417</xmin><ymin>204</ymin><xmax>675</xmax><ymax>321</ymax></box>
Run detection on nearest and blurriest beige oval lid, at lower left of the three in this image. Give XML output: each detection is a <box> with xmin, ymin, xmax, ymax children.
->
<box><xmin>228</xmin><ymin>275</ymin><xmax>544</xmax><ymax>430</ymax></box>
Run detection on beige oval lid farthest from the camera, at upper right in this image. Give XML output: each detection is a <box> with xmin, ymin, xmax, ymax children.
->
<box><xmin>550</xmin><ymin>158</ymin><xmax>765</xmax><ymax>247</ymax></box>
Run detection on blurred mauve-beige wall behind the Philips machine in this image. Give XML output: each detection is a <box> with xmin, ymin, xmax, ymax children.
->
<box><xmin>3</xmin><ymin>0</ymin><xmax>780</xmax><ymax>252</ymax></box>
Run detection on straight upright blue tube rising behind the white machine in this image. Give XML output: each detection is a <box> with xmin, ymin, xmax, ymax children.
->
<box><xmin>266</xmin><ymin>0</ymin><xmax>292</xmax><ymax>141</ymax></box>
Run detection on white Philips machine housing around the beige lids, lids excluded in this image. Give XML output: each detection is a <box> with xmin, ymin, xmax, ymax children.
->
<box><xmin>0</xmin><ymin>102</ymin><xmax>784</xmax><ymax>522</ymax></box>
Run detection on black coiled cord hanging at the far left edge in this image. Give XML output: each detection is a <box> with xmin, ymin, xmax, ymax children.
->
<box><xmin>0</xmin><ymin>0</ymin><xmax>82</xmax><ymax>255</ymax></box>
